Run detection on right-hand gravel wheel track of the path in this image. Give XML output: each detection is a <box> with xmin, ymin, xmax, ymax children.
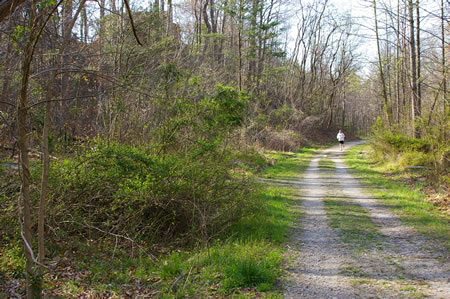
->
<box><xmin>331</xmin><ymin>144</ymin><xmax>450</xmax><ymax>298</ymax></box>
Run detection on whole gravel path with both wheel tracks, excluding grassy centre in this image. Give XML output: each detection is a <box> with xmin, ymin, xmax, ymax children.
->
<box><xmin>285</xmin><ymin>143</ymin><xmax>450</xmax><ymax>298</ymax></box>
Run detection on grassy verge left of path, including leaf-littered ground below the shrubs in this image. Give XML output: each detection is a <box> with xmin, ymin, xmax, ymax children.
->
<box><xmin>0</xmin><ymin>149</ymin><xmax>315</xmax><ymax>298</ymax></box>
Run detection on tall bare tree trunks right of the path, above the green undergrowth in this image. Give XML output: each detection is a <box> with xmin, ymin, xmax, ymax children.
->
<box><xmin>372</xmin><ymin>0</ymin><xmax>450</xmax><ymax>137</ymax></box>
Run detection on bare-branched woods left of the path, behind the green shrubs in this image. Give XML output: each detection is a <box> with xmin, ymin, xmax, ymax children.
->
<box><xmin>0</xmin><ymin>0</ymin><xmax>378</xmax><ymax>152</ymax></box>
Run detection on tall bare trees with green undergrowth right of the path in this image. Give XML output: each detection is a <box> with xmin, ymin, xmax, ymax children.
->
<box><xmin>372</xmin><ymin>0</ymin><xmax>450</xmax><ymax>185</ymax></box>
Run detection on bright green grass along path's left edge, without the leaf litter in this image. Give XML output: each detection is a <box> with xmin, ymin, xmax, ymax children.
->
<box><xmin>70</xmin><ymin>149</ymin><xmax>314</xmax><ymax>298</ymax></box>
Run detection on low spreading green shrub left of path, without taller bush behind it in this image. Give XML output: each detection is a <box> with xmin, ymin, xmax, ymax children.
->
<box><xmin>49</xmin><ymin>140</ymin><xmax>256</xmax><ymax>245</ymax></box>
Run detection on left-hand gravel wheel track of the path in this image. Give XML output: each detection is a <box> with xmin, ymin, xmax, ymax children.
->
<box><xmin>285</xmin><ymin>147</ymin><xmax>357</xmax><ymax>298</ymax></box>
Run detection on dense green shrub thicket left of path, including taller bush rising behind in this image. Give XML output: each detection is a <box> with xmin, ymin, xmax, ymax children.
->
<box><xmin>44</xmin><ymin>86</ymin><xmax>256</xmax><ymax>246</ymax></box>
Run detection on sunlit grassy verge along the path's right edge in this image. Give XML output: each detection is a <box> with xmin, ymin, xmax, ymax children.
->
<box><xmin>346</xmin><ymin>145</ymin><xmax>450</xmax><ymax>249</ymax></box>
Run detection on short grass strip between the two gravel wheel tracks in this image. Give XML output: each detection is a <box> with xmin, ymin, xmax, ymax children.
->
<box><xmin>319</xmin><ymin>159</ymin><xmax>381</xmax><ymax>250</ymax></box>
